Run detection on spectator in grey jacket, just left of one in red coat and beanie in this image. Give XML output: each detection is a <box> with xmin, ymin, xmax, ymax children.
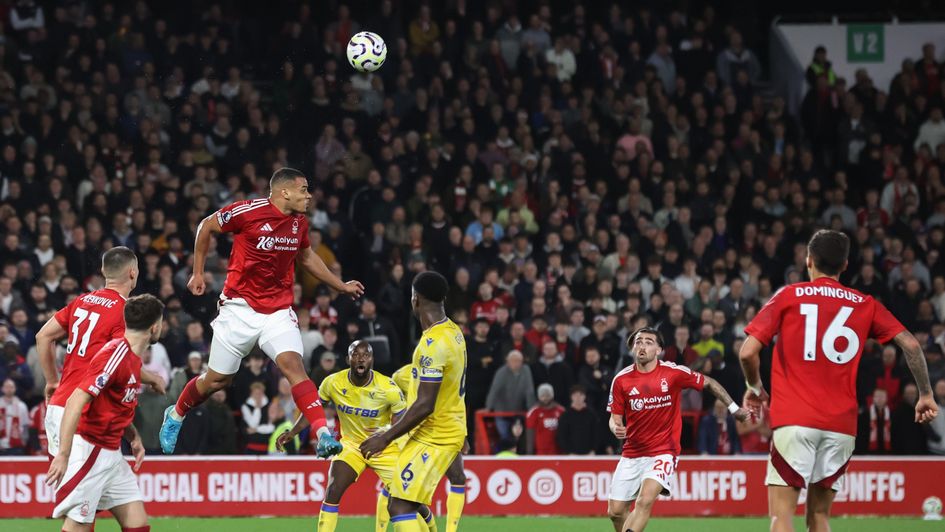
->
<box><xmin>486</xmin><ymin>349</ymin><xmax>535</xmax><ymax>440</ymax></box>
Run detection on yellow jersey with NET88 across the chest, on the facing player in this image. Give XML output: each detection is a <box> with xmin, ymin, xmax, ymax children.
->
<box><xmin>318</xmin><ymin>369</ymin><xmax>407</xmax><ymax>446</ymax></box>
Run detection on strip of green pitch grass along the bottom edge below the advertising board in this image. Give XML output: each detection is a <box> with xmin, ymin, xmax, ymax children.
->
<box><xmin>0</xmin><ymin>511</ymin><xmax>943</xmax><ymax>532</ymax></box>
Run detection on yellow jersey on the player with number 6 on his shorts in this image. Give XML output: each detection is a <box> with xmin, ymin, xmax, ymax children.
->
<box><xmin>407</xmin><ymin>318</ymin><xmax>466</xmax><ymax>448</ymax></box>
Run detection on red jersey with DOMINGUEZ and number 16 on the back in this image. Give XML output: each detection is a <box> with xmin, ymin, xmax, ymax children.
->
<box><xmin>745</xmin><ymin>277</ymin><xmax>905</xmax><ymax>436</ymax></box>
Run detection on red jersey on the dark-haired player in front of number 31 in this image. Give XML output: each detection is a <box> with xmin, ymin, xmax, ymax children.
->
<box><xmin>77</xmin><ymin>338</ymin><xmax>141</xmax><ymax>450</ymax></box>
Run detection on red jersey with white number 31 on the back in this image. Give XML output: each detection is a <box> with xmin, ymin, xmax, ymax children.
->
<box><xmin>49</xmin><ymin>288</ymin><xmax>125</xmax><ymax>406</ymax></box>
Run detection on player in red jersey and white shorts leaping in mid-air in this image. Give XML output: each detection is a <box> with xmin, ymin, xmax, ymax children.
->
<box><xmin>159</xmin><ymin>168</ymin><xmax>364</xmax><ymax>457</ymax></box>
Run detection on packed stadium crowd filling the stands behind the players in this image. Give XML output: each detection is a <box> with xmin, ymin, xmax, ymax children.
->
<box><xmin>0</xmin><ymin>0</ymin><xmax>945</xmax><ymax>454</ymax></box>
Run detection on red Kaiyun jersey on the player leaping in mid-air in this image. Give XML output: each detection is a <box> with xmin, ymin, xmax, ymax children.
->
<box><xmin>217</xmin><ymin>199</ymin><xmax>311</xmax><ymax>314</ymax></box>
